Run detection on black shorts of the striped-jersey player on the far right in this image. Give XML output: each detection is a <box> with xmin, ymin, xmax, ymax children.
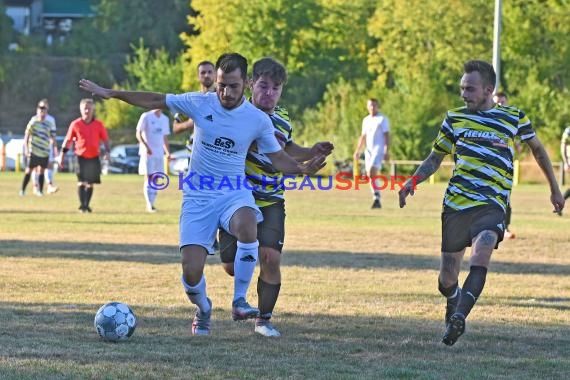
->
<box><xmin>441</xmin><ymin>205</ymin><xmax>505</xmax><ymax>252</ymax></box>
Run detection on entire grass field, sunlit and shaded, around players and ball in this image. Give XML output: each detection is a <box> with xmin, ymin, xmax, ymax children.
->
<box><xmin>0</xmin><ymin>173</ymin><xmax>570</xmax><ymax>379</ymax></box>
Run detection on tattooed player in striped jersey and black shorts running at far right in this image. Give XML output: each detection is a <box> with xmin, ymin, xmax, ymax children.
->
<box><xmin>399</xmin><ymin>60</ymin><xmax>564</xmax><ymax>346</ymax></box>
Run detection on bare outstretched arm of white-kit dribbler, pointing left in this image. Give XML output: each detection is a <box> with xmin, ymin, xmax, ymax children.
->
<box><xmin>79</xmin><ymin>79</ymin><xmax>166</xmax><ymax>109</ymax></box>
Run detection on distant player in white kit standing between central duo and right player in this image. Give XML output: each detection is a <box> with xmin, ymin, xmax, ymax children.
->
<box><xmin>354</xmin><ymin>98</ymin><xmax>390</xmax><ymax>208</ymax></box>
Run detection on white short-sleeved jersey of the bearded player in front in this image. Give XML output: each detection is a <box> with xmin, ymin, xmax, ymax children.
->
<box><xmin>166</xmin><ymin>92</ymin><xmax>281</xmax><ymax>198</ymax></box>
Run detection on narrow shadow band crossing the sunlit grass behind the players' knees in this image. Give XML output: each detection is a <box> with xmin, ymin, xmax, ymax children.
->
<box><xmin>0</xmin><ymin>240</ymin><xmax>570</xmax><ymax>275</ymax></box>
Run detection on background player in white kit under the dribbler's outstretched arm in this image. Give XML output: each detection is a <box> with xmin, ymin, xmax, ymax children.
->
<box><xmin>137</xmin><ymin>109</ymin><xmax>170</xmax><ymax>212</ymax></box>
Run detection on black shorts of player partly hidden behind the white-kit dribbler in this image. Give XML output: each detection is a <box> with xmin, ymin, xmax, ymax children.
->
<box><xmin>219</xmin><ymin>201</ymin><xmax>285</xmax><ymax>263</ymax></box>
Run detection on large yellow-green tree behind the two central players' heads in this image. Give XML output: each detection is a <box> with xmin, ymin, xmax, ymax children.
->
<box><xmin>182</xmin><ymin>0</ymin><xmax>374</xmax><ymax>115</ymax></box>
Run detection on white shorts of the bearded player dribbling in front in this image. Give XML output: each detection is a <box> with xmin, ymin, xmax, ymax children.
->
<box><xmin>180</xmin><ymin>190</ymin><xmax>263</xmax><ymax>255</ymax></box>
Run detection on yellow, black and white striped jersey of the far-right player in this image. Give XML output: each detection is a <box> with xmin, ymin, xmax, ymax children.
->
<box><xmin>432</xmin><ymin>105</ymin><xmax>536</xmax><ymax>210</ymax></box>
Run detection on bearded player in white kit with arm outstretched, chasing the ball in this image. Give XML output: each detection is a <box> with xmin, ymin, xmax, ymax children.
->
<box><xmin>79</xmin><ymin>53</ymin><xmax>326</xmax><ymax>335</ymax></box>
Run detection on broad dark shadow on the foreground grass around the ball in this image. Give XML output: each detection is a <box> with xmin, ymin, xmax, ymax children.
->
<box><xmin>0</xmin><ymin>302</ymin><xmax>570</xmax><ymax>379</ymax></box>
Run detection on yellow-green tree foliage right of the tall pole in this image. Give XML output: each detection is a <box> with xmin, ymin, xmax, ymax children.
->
<box><xmin>501</xmin><ymin>0</ymin><xmax>570</xmax><ymax>151</ymax></box>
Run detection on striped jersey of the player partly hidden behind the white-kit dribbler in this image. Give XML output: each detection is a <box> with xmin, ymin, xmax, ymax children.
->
<box><xmin>245</xmin><ymin>106</ymin><xmax>293</xmax><ymax>207</ymax></box>
